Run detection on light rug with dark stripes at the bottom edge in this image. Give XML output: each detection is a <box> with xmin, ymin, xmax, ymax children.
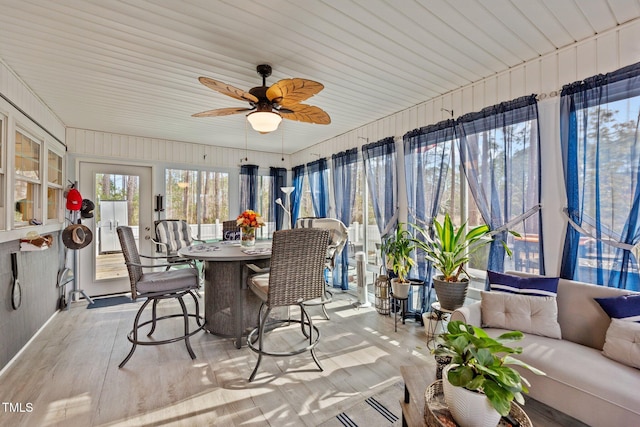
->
<box><xmin>320</xmin><ymin>381</ymin><xmax>404</xmax><ymax>427</ymax></box>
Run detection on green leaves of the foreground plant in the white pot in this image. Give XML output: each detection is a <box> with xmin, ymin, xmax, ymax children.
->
<box><xmin>433</xmin><ymin>320</ymin><xmax>545</xmax><ymax>416</ymax></box>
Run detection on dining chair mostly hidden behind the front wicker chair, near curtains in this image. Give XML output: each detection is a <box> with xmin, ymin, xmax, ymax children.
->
<box><xmin>296</xmin><ymin>218</ymin><xmax>349</xmax><ymax>320</ymax></box>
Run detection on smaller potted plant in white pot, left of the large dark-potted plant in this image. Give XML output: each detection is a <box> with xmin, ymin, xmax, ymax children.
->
<box><xmin>380</xmin><ymin>222</ymin><xmax>415</xmax><ymax>299</ymax></box>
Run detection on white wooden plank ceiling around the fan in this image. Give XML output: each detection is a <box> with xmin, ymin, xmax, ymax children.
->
<box><xmin>0</xmin><ymin>0</ymin><xmax>640</xmax><ymax>153</ymax></box>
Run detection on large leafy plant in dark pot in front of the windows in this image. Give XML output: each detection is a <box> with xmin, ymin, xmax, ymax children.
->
<box><xmin>413</xmin><ymin>213</ymin><xmax>518</xmax><ymax>310</ymax></box>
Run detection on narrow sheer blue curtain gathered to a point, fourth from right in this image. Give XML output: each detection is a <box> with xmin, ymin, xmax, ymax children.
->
<box><xmin>362</xmin><ymin>137</ymin><xmax>398</xmax><ymax>239</ymax></box>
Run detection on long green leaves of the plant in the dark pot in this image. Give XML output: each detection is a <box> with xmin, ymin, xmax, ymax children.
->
<box><xmin>412</xmin><ymin>213</ymin><xmax>518</xmax><ymax>282</ymax></box>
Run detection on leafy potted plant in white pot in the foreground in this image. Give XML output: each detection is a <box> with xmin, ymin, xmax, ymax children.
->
<box><xmin>433</xmin><ymin>320</ymin><xmax>545</xmax><ymax>427</ymax></box>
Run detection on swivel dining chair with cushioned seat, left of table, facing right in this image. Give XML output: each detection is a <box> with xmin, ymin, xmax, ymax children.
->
<box><xmin>116</xmin><ymin>226</ymin><xmax>205</xmax><ymax>368</ymax></box>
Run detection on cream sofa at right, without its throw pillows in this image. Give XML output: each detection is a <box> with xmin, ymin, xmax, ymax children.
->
<box><xmin>451</xmin><ymin>272</ymin><xmax>640</xmax><ymax>427</ymax></box>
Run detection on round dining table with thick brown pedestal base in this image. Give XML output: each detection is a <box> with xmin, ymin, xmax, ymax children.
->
<box><xmin>178</xmin><ymin>240</ymin><xmax>271</xmax><ymax>348</ymax></box>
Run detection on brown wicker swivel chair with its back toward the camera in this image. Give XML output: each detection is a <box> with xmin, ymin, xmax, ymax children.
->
<box><xmin>247</xmin><ymin>228</ymin><xmax>329</xmax><ymax>381</ymax></box>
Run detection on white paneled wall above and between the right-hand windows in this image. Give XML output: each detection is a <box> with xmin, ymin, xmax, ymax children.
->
<box><xmin>291</xmin><ymin>20</ymin><xmax>640</xmax><ymax>274</ymax></box>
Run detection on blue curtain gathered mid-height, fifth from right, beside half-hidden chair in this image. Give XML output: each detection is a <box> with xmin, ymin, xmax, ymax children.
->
<box><xmin>331</xmin><ymin>148</ymin><xmax>358</xmax><ymax>290</ymax></box>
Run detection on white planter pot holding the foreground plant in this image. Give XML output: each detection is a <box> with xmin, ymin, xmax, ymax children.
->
<box><xmin>442</xmin><ymin>365</ymin><xmax>500</xmax><ymax>427</ymax></box>
